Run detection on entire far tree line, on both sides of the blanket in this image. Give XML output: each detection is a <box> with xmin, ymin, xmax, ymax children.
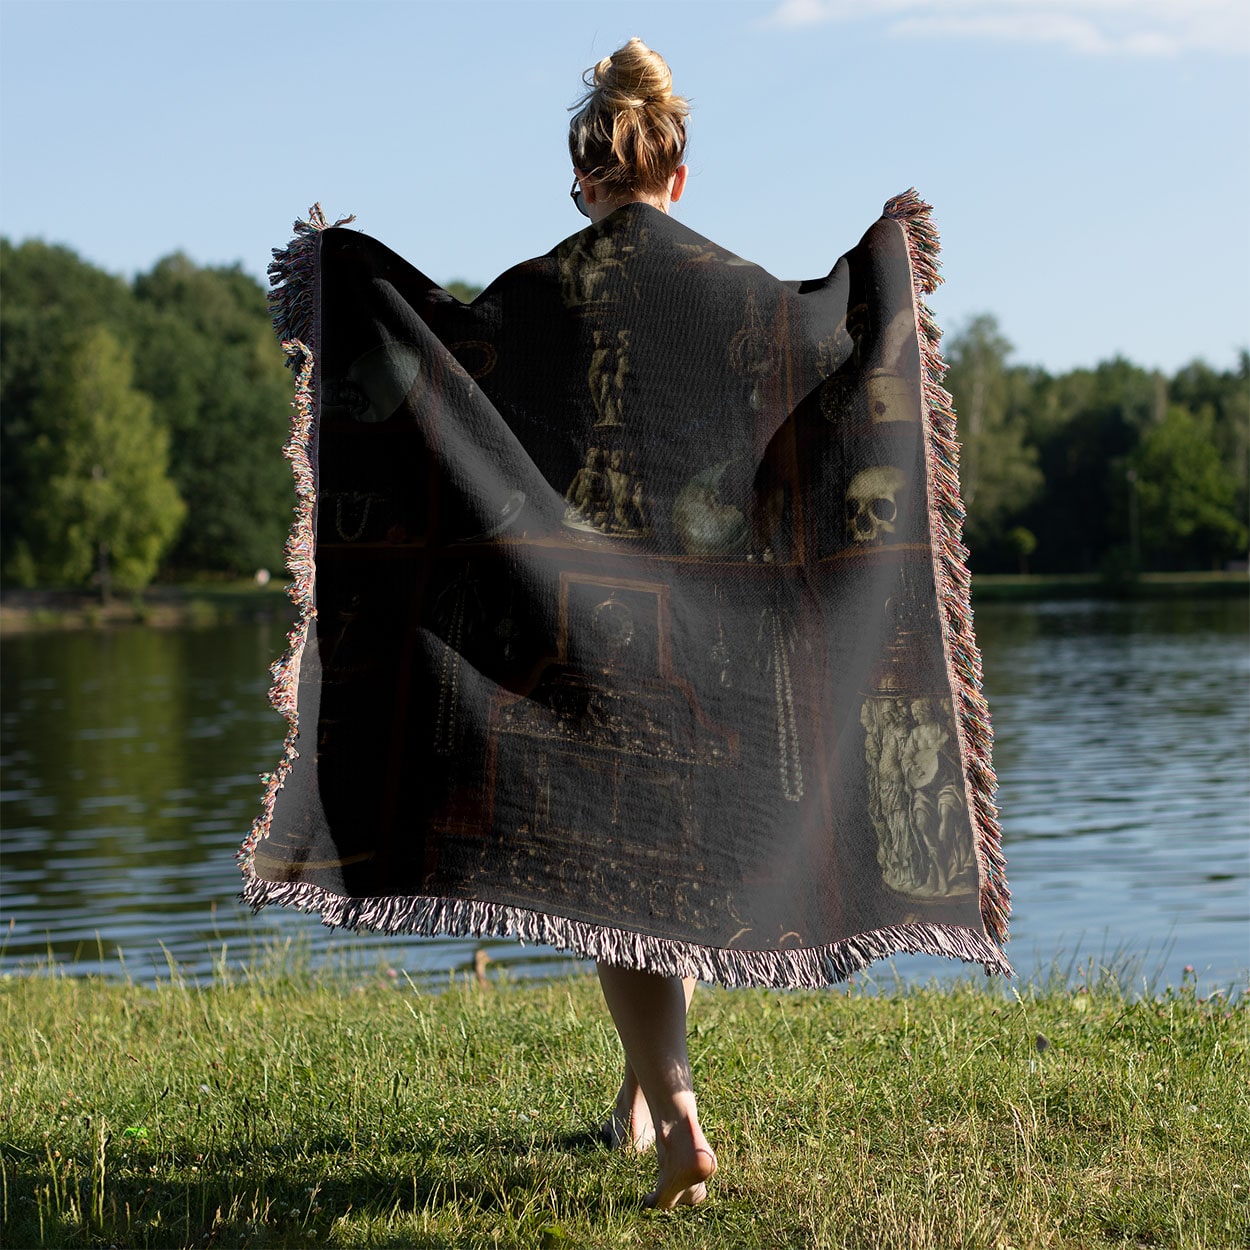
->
<box><xmin>0</xmin><ymin>239</ymin><xmax>1250</xmax><ymax>595</ymax></box>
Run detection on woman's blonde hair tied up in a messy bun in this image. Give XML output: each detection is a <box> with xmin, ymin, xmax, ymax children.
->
<box><xmin>569</xmin><ymin>39</ymin><xmax>690</xmax><ymax>196</ymax></box>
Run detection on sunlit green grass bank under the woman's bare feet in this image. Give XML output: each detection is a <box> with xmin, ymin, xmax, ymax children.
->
<box><xmin>0</xmin><ymin>970</ymin><xmax>1250</xmax><ymax>1250</ymax></box>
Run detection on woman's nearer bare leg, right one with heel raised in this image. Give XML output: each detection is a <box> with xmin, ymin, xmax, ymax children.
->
<box><xmin>599</xmin><ymin>964</ymin><xmax>716</xmax><ymax>1209</ymax></box>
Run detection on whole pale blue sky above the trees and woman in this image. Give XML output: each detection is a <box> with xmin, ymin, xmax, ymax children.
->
<box><xmin>0</xmin><ymin>0</ymin><xmax>1250</xmax><ymax>371</ymax></box>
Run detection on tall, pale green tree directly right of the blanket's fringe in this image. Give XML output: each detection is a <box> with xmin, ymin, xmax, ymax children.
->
<box><xmin>945</xmin><ymin>315</ymin><xmax>1043</xmax><ymax>565</ymax></box>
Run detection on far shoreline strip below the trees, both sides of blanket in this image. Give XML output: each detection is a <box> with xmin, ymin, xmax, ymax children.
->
<box><xmin>0</xmin><ymin>573</ymin><xmax>1250</xmax><ymax>638</ymax></box>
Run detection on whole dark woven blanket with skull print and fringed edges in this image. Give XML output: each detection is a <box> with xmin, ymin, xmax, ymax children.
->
<box><xmin>240</xmin><ymin>191</ymin><xmax>1011</xmax><ymax>986</ymax></box>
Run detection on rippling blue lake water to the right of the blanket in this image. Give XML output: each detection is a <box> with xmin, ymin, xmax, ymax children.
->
<box><xmin>978</xmin><ymin>599</ymin><xmax>1250</xmax><ymax>985</ymax></box>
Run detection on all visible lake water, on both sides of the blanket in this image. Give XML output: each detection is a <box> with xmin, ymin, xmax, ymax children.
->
<box><xmin>0</xmin><ymin>599</ymin><xmax>1250</xmax><ymax>989</ymax></box>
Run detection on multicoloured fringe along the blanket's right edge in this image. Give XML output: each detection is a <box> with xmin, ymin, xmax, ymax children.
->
<box><xmin>883</xmin><ymin>188</ymin><xmax>1011</xmax><ymax>943</ymax></box>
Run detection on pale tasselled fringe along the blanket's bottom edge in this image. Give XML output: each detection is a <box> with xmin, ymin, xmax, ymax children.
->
<box><xmin>244</xmin><ymin>876</ymin><xmax>1011</xmax><ymax>990</ymax></box>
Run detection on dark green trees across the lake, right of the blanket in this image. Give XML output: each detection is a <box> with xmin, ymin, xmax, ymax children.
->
<box><xmin>945</xmin><ymin>316</ymin><xmax>1250</xmax><ymax>578</ymax></box>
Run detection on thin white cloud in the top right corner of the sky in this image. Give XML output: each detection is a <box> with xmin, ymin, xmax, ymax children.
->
<box><xmin>769</xmin><ymin>0</ymin><xmax>1250</xmax><ymax>58</ymax></box>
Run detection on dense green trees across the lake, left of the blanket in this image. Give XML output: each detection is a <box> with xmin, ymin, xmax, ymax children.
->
<box><xmin>0</xmin><ymin>240</ymin><xmax>291</xmax><ymax>593</ymax></box>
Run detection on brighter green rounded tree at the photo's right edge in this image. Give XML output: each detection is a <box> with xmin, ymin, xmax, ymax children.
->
<box><xmin>1131</xmin><ymin>404</ymin><xmax>1246</xmax><ymax>568</ymax></box>
